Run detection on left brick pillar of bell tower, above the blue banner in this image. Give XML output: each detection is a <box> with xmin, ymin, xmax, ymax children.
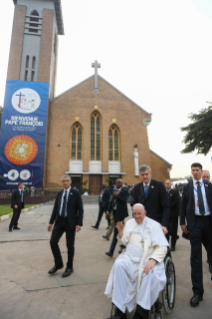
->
<box><xmin>7</xmin><ymin>4</ymin><xmax>27</xmax><ymax>80</ymax></box>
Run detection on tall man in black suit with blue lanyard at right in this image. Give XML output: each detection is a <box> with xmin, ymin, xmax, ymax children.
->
<box><xmin>180</xmin><ymin>163</ymin><xmax>212</xmax><ymax>307</ymax></box>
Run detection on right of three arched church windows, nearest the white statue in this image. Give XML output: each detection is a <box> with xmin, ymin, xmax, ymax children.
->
<box><xmin>109</xmin><ymin>125</ymin><xmax>120</xmax><ymax>161</ymax></box>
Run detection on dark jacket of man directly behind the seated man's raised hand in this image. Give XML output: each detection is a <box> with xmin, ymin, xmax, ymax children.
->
<box><xmin>107</xmin><ymin>187</ymin><xmax>129</xmax><ymax>223</ymax></box>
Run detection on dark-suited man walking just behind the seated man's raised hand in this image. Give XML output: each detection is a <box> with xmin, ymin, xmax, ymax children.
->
<box><xmin>105</xmin><ymin>179</ymin><xmax>129</xmax><ymax>257</ymax></box>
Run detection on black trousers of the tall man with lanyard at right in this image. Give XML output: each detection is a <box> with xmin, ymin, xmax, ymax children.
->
<box><xmin>189</xmin><ymin>216</ymin><xmax>212</xmax><ymax>295</ymax></box>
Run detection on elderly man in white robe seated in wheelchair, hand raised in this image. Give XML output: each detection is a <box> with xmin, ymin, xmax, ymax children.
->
<box><xmin>105</xmin><ymin>204</ymin><xmax>168</xmax><ymax>319</ymax></box>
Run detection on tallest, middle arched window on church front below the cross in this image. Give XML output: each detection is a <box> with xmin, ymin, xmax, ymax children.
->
<box><xmin>90</xmin><ymin>112</ymin><xmax>101</xmax><ymax>161</ymax></box>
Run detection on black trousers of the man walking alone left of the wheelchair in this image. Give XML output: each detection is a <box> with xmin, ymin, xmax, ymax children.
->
<box><xmin>50</xmin><ymin>217</ymin><xmax>75</xmax><ymax>268</ymax></box>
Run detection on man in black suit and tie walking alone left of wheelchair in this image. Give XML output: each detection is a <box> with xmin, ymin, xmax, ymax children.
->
<box><xmin>48</xmin><ymin>175</ymin><xmax>83</xmax><ymax>278</ymax></box>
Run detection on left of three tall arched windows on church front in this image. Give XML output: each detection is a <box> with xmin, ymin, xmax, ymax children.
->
<box><xmin>71</xmin><ymin>123</ymin><xmax>82</xmax><ymax>160</ymax></box>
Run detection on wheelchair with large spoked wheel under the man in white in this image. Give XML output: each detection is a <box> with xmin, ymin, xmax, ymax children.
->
<box><xmin>110</xmin><ymin>250</ymin><xmax>176</xmax><ymax>319</ymax></box>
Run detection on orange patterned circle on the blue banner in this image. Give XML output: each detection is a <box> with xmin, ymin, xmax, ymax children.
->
<box><xmin>4</xmin><ymin>135</ymin><xmax>38</xmax><ymax>165</ymax></box>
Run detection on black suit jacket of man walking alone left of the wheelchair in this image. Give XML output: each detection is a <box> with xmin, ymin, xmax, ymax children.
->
<box><xmin>49</xmin><ymin>188</ymin><xmax>83</xmax><ymax>229</ymax></box>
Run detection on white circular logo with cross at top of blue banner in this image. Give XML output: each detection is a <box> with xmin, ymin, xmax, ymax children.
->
<box><xmin>11</xmin><ymin>89</ymin><xmax>41</xmax><ymax>114</ymax></box>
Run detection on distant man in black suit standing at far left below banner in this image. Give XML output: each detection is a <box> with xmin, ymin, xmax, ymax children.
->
<box><xmin>9</xmin><ymin>183</ymin><xmax>24</xmax><ymax>232</ymax></box>
